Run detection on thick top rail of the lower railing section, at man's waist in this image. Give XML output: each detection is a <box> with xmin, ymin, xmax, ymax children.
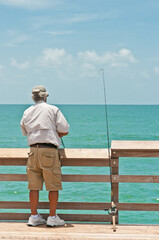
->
<box><xmin>0</xmin><ymin>148</ymin><xmax>109</xmax><ymax>167</ymax></box>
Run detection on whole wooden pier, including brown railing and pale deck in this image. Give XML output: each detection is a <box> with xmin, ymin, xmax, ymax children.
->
<box><xmin>0</xmin><ymin>141</ymin><xmax>159</xmax><ymax>240</ymax></box>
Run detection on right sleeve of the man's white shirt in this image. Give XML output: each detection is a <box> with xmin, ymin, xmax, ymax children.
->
<box><xmin>56</xmin><ymin>109</ymin><xmax>69</xmax><ymax>133</ymax></box>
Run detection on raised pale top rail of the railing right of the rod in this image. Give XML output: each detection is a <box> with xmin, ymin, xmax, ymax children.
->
<box><xmin>111</xmin><ymin>141</ymin><xmax>159</xmax><ymax>157</ymax></box>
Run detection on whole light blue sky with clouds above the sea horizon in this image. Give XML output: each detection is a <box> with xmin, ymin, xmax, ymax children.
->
<box><xmin>0</xmin><ymin>0</ymin><xmax>159</xmax><ymax>104</ymax></box>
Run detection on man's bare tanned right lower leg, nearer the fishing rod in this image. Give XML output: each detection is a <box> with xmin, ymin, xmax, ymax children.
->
<box><xmin>49</xmin><ymin>191</ymin><xmax>59</xmax><ymax>216</ymax></box>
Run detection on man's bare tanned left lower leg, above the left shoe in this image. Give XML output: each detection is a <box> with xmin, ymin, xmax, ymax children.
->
<box><xmin>29</xmin><ymin>190</ymin><xmax>39</xmax><ymax>215</ymax></box>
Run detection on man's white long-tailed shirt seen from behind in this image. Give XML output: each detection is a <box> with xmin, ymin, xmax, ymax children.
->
<box><xmin>20</xmin><ymin>101</ymin><xmax>69</xmax><ymax>147</ymax></box>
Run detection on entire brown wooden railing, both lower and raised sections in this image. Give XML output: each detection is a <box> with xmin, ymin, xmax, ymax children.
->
<box><xmin>0</xmin><ymin>141</ymin><xmax>159</xmax><ymax>223</ymax></box>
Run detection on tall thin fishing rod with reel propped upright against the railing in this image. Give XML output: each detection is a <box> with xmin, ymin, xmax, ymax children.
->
<box><xmin>99</xmin><ymin>68</ymin><xmax>117</xmax><ymax>232</ymax></box>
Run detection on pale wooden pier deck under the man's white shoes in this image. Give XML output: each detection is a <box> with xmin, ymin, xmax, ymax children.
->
<box><xmin>0</xmin><ymin>222</ymin><xmax>159</xmax><ymax>240</ymax></box>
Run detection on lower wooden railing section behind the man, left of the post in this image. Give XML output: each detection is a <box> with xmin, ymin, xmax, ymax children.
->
<box><xmin>0</xmin><ymin>149</ymin><xmax>111</xmax><ymax>222</ymax></box>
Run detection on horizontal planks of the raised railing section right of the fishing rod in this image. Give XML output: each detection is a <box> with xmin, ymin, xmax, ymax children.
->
<box><xmin>111</xmin><ymin>141</ymin><xmax>159</xmax><ymax>214</ymax></box>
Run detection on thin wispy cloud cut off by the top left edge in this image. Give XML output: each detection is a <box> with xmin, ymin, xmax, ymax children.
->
<box><xmin>0</xmin><ymin>0</ymin><xmax>61</xmax><ymax>10</ymax></box>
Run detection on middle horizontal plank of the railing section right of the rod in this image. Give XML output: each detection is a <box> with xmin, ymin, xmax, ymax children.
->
<box><xmin>112</xmin><ymin>175</ymin><xmax>159</xmax><ymax>183</ymax></box>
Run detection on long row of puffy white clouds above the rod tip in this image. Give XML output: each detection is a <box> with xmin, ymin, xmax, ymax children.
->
<box><xmin>40</xmin><ymin>48</ymin><xmax>137</xmax><ymax>67</ymax></box>
